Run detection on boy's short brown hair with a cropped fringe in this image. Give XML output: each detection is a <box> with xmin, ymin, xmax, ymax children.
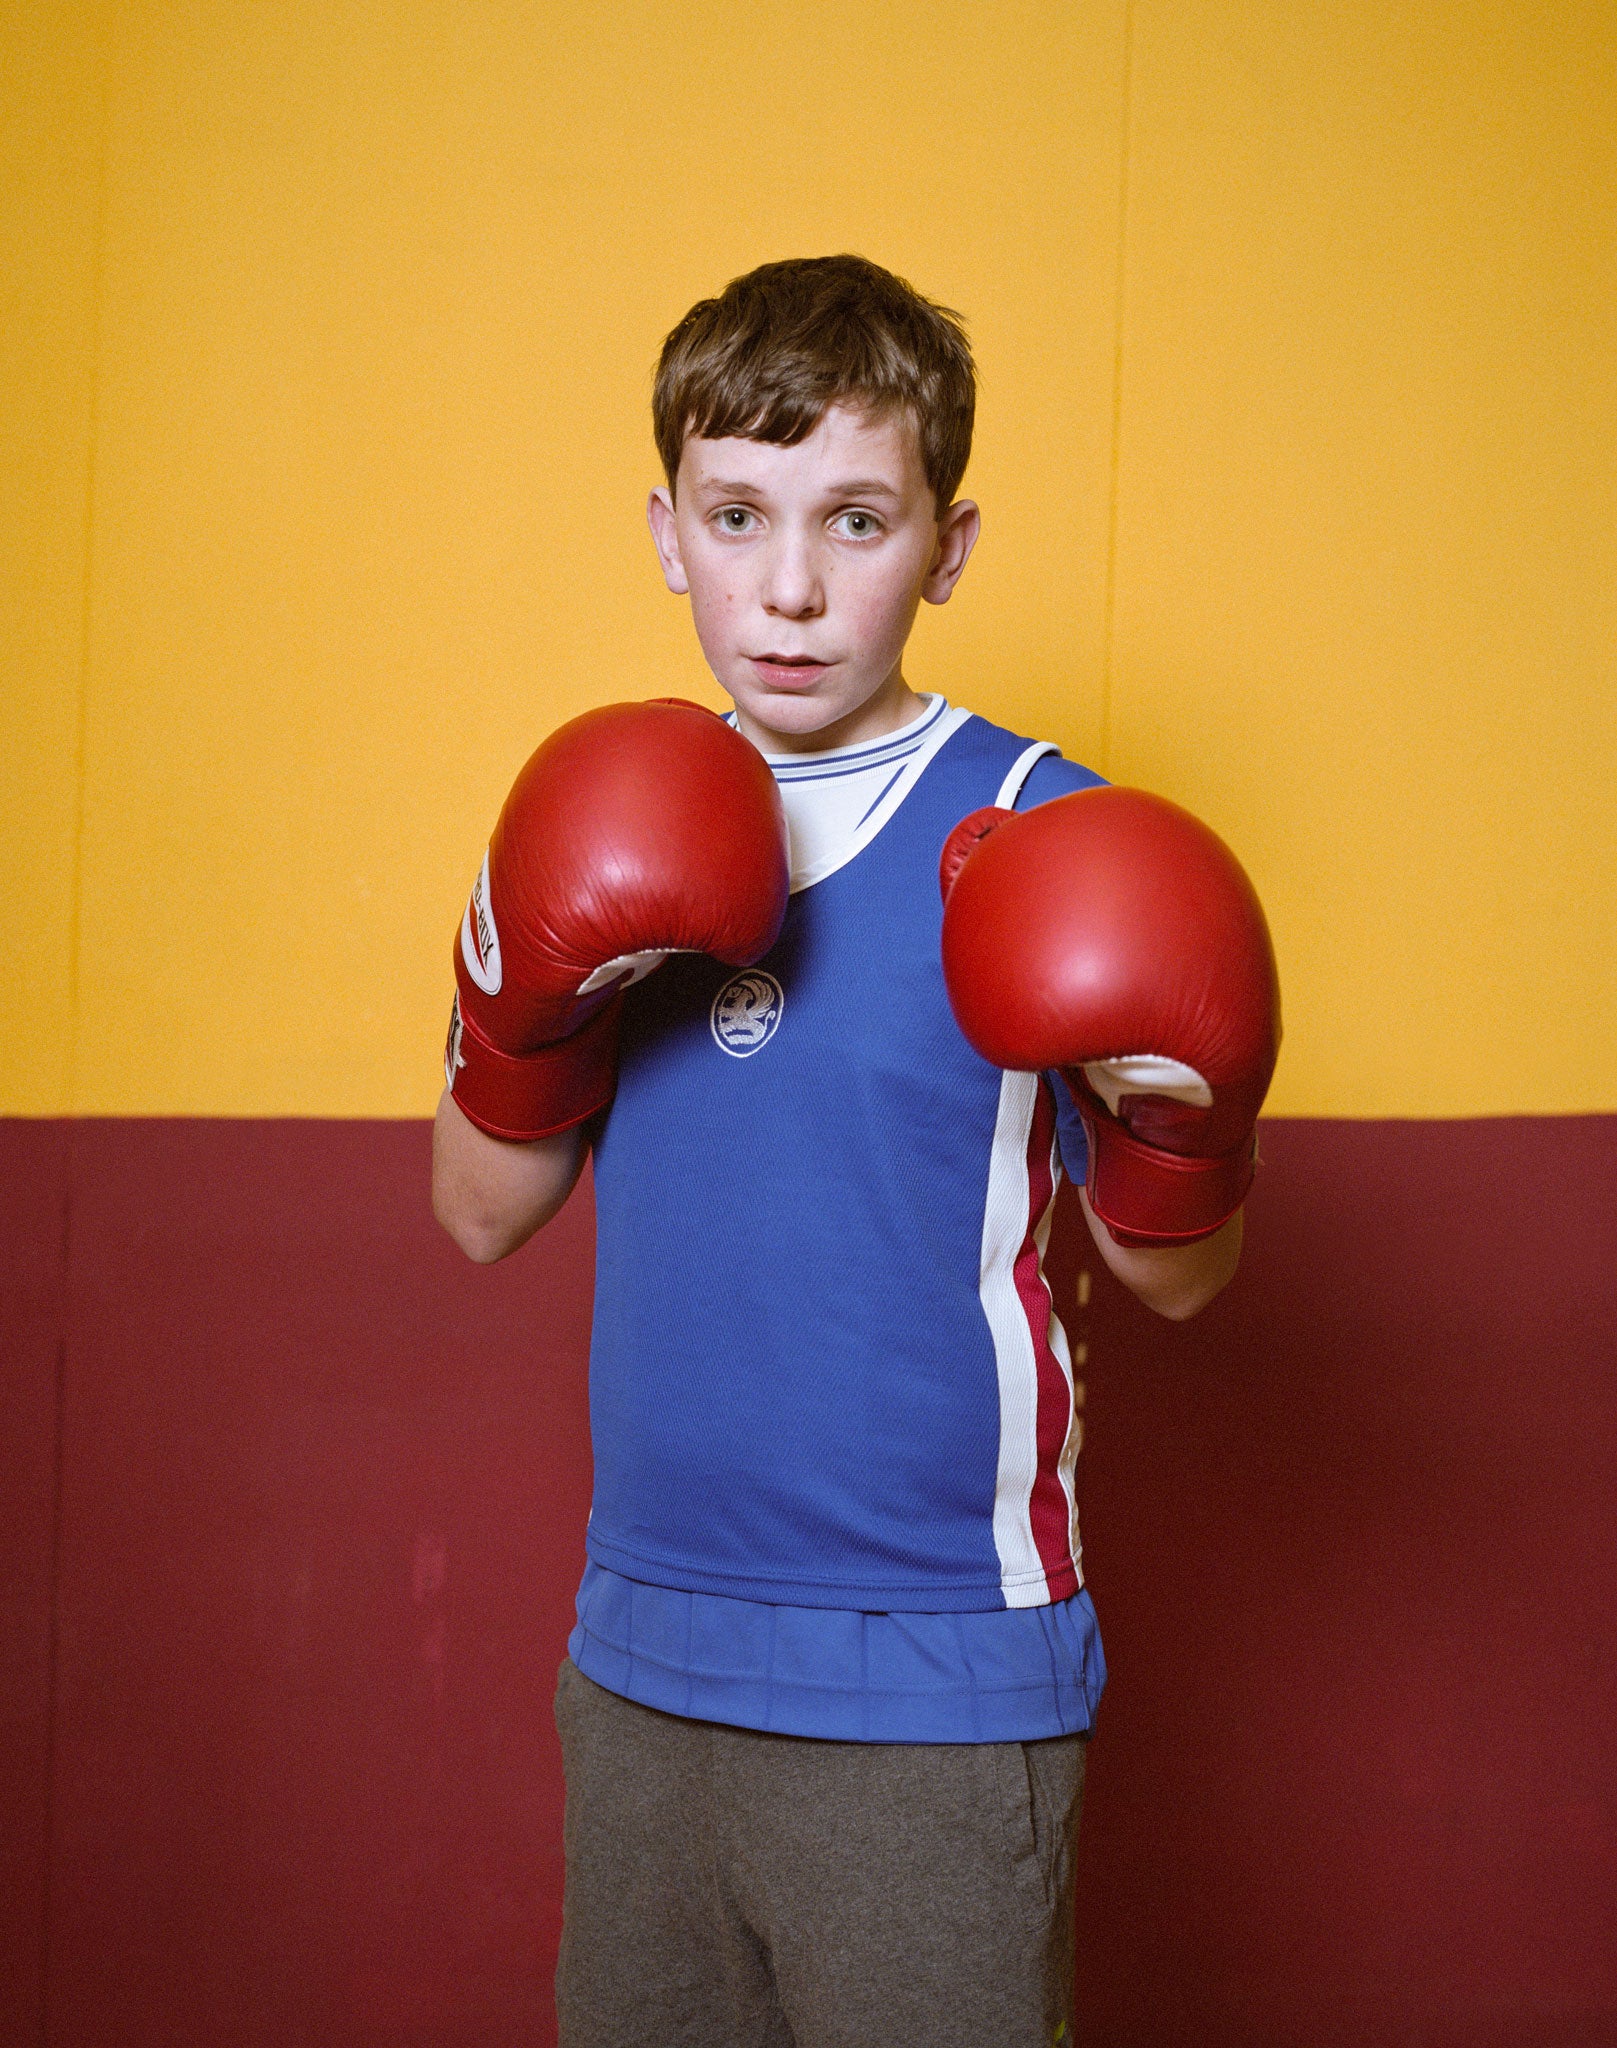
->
<box><xmin>651</xmin><ymin>256</ymin><xmax>976</xmax><ymax>514</ymax></box>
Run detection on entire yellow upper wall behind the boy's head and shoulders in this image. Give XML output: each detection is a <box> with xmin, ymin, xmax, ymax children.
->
<box><xmin>0</xmin><ymin>0</ymin><xmax>1617</xmax><ymax>1116</ymax></box>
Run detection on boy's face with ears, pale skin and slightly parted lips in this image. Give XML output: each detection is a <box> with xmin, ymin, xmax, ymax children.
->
<box><xmin>647</xmin><ymin>406</ymin><xmax>978</xmax><ymax>752</ymax></box>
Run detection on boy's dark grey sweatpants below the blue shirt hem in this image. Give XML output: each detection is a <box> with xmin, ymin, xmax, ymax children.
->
<box><xmin>557</xmin><ymin>1659</ymin><xmax>1085</xmax><ymax>2048</ymax></box>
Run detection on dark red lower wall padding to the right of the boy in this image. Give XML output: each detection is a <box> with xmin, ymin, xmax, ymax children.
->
<box><xmin>1047</xmin><ymin>1116</ymin><xmax>1617</xmax><ymax>2048</ymax></box>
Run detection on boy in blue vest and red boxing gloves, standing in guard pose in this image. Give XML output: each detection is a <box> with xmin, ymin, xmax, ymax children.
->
<box><xmin>434</xmin><ymin>256</ymin><xmax>1277</xmax><ymax>2048</ymax></box>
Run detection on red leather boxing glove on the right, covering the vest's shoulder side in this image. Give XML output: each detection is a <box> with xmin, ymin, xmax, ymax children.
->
<box><xmin>939</xmin><ymin>788</ymin><xmax>1279</xmax><ymax>1245</ymax></box>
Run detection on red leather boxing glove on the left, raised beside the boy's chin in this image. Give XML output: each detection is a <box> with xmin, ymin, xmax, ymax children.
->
<box><xmin>444</xmin><ymin>696</ymin><xmax>788</xmax><ymax>1139</ymax></box>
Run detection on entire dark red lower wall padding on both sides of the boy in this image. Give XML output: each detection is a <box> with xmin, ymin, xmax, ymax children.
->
<box><xmin>0</xmin><ymin>1118</ymin><xmax>1617</xmax><ymax>2048</ymax></box>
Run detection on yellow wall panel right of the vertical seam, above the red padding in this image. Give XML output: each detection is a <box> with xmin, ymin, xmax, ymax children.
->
<box><xmin>1109</xmin><ymin>0</ymin><xmax>1617</xmax><ymax>1116</ymax></box>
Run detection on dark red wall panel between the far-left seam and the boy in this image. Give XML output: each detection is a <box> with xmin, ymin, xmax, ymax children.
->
<box><xmin>8</xmin><ymin>1122</ymin><xmax>594</xmax><ymax>2048</ymax></box>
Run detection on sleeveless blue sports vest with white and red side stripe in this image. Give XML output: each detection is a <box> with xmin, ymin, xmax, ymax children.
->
<box><xmin>589</xmin><ymin>717</ymin><xmax>1105</xmax><ymax>1612</ymax></box>
